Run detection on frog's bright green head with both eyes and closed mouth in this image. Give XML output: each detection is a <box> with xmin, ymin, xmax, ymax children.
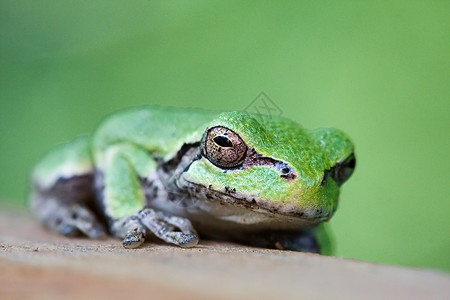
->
<box><xmin>183</xmin><ymin>112</ymin><xmax>355</xmax><ymax>223</ymax></box>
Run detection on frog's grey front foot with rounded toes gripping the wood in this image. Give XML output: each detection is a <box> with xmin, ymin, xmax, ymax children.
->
<box><xmin>112</xmin><ymin>208</ymin><xmax>199</xmax><ymax>249</ymax></box>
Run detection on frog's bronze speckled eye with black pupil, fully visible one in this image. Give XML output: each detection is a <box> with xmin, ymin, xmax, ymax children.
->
<box><xmin>204</xmin><ymin>126</ymin><xmax>247</xmax><ymax>168</ymax></box>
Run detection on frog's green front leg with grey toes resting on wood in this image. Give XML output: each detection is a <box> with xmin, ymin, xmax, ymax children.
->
<box><xmin>97</xmin><ymin>144</ymin><xmax>199</xmax><ymax>248</ymax></box>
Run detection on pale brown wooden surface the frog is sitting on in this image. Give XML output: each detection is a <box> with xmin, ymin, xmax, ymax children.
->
<box><xmin>0</xmin><ymin>210</ymin><xmax>450</xmax><ymax>299</ymax></box>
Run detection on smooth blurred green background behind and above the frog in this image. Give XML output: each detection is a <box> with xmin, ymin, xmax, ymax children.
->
<box><xmin>0</xmin><ymin>0</ymin><xmax>450</xmax><ymax>270</ymax></box>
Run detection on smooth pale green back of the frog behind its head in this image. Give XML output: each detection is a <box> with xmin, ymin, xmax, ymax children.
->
<box><xmin>93</xmin><ymin>106</ymin><xmax>220</xmax><ymax>158</ymax></box>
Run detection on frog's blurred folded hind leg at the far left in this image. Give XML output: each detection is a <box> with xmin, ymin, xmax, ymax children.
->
<box><xmin>30</xmin><ymin>136</ymin><xmax>105</xmax><ymax>238</ymax></box>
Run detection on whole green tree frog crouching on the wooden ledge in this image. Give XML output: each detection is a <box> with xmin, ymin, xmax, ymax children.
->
<box><xmin>30</xmin><ymin>106</ymin><xmax>355</xmax><ymax>252</ymax></box>
